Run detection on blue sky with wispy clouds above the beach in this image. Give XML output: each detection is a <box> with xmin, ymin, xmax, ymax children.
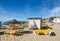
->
<box><xmin>0</xmin><ymin>0</ymin><xmax>60</xmax><ymax>21</ymax></box>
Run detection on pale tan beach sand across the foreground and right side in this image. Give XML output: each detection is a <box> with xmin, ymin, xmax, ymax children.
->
<box><xmin>0</xmin><ymin>24</ymin><xmax>60</xmax><ymax>41</ymax></box>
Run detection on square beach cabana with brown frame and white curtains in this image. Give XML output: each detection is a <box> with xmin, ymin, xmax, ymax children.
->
<box><xmin>28</xmin><ymin>18</ymin><xmax>42</xmax><ymax>29</ymax></box>
